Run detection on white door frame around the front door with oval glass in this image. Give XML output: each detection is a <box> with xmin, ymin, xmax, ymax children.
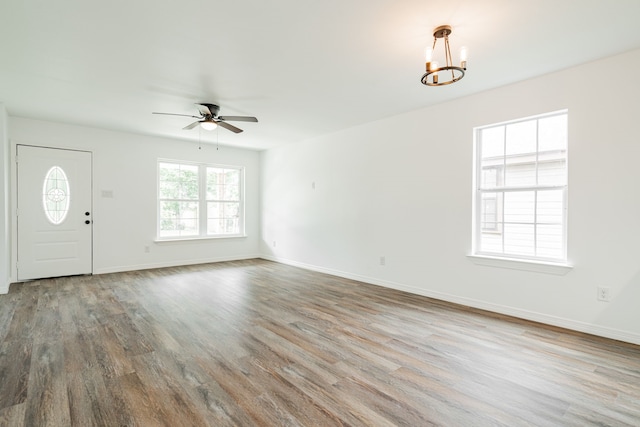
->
<box><xmin>10</xmin><ymin>145</ymin><xmax>96</xmax><ymax>283</ymax></box>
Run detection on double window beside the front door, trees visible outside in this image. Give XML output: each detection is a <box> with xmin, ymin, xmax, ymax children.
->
<box><xmin>158</xmin><ymin>161</ymin><xmax>244</xmax><ymax>239</ymax></box>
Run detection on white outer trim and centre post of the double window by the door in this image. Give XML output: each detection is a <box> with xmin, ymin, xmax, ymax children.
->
<box><xmin>154</xmin><ymin>158</ymin><xmax>247</xmax><ymax>243</ymax></box>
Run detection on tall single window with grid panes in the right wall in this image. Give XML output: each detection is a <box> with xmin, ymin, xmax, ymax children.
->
<box><xmin>473</xmin><ymin>111</ymin><xmax>568</xmax><ymax>262</ymax></box>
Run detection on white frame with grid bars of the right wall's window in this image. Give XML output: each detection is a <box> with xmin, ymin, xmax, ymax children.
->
<box><xmin>472</xmin><ymin>109</ymin><xmax>569</xmax><ymax>265</ymax></box>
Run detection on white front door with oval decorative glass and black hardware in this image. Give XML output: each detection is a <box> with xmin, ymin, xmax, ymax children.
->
<box><xmin>17</xmin><ymin>145</ymin><xmax>93</xmax><ymax>280</ymax></box>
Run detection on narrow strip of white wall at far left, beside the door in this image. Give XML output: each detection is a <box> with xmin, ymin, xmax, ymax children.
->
<box><xmin>0</xmin><ymin>103</ymin><xmax>11</xmax><ymax>294</ymax></box>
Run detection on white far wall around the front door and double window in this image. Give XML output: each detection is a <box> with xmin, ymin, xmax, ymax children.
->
<box><xmin>9</xmin><ymin>117</ymin><xmax>260</xmax><ymax>280</ymax></box>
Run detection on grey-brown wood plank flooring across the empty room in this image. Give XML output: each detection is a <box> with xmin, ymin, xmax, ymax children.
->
<box><xmin>0</xmin><ymin>260</ymin><xmax>640</xmax><ymax>427</ymax></box>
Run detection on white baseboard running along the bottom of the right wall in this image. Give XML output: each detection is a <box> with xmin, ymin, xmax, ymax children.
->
<box><xmin>260</xmin><ymin>255</ymin><xmax>640</xmax><ymax>345</ymax></box>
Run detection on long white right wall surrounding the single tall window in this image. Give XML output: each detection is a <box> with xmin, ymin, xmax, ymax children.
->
<box><xmin>261</xmin><ymin>51</ymin><xmax>640</xmax><ymax>344</ymax></box>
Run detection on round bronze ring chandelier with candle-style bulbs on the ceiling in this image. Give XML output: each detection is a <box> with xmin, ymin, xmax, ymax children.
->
<box><xmin>420</xmin><ymin>25</ymin><xmax>467</xmax><ymax>86</ymax></box>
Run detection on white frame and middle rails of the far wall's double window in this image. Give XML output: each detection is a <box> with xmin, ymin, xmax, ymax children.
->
<box><xmin>156</xmin><ymin>158</ymin><xmax>246</xmax><ymax>242</ymax></box>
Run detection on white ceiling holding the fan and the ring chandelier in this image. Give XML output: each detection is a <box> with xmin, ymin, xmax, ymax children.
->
<box><xmin>0</xmin><ymin>0</ymin><xmax>640</xmax><ymax>149</ymax></box>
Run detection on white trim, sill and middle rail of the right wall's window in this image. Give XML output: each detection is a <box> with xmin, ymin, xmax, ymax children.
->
<box><xmin>467</xmin><ymin>109</ymin><xmax>573</xmax><ymax>264</ymax></box>
